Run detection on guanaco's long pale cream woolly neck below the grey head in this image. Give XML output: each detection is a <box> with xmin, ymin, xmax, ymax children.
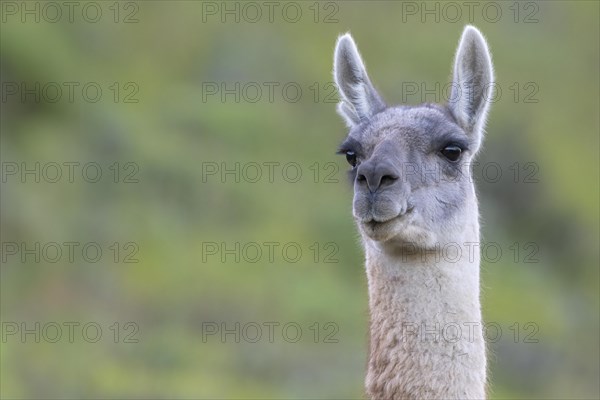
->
<box><xmin>365</xmin><ymin>218</ymin><xmax>486</xmax><ymax>399</ymax></box>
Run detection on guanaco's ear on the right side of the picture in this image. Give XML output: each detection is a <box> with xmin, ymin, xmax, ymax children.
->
<box><xmin>448</xmin><ymin>25</ymin><xmax>494</xmax><ymax>152</ymax></box>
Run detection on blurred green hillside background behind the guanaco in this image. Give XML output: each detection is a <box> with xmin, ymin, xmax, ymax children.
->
<box><xmin>0</xmin><ymin>1</ymin><xmax>600</xmax><ymax>399</ymax></box>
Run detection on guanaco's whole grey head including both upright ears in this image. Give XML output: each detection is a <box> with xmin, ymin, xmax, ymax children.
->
<box><xmin>334</xmin><ymin>26</ymin><xmax>493</xmax><ymax>248</ymax></box>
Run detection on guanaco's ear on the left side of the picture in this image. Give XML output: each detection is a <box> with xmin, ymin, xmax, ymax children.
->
<box><xmin>333</xmin><ymin>33</ymin><xmax>385</xmax><ymax>127</ymax></box>
